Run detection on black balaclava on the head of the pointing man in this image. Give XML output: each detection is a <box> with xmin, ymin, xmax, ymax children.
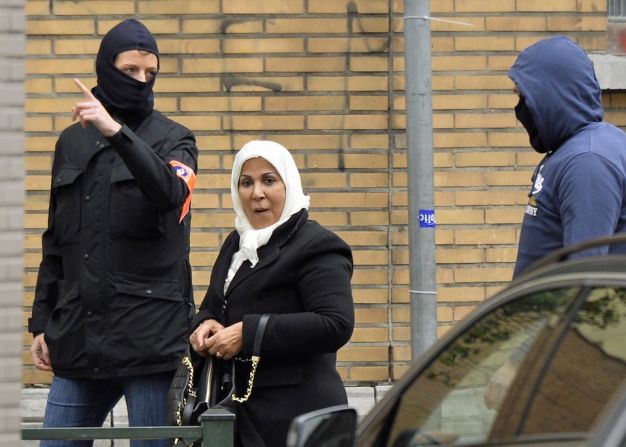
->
<box><xmin>92</xmin><ymin>19</ymin><xmax>159</xmax><ymax>124</ymax></box>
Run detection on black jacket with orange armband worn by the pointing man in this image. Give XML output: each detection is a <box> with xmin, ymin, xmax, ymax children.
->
<box><xmin>29</xmin><ymin>111</ymin><xmax>198</xmax><ymax>378</ymax></box>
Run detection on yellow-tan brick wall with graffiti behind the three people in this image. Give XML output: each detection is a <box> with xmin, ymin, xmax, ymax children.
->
<box><xmin>24</xmin><ymin>0</ymin><xmax>626</xmax><ymax>384</ymax></box>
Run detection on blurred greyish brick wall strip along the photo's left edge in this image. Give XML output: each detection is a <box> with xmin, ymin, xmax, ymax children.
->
<box><xmin>0</xmin><ymin>0</ymin><xmax>26</xmax><ymax>447</ymax></box>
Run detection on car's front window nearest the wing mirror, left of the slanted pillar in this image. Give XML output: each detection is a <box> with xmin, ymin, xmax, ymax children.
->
<box><xmin>359</xmin><ymin>288</ymin><xmax>579</xmax><ymax>447</ymax></box>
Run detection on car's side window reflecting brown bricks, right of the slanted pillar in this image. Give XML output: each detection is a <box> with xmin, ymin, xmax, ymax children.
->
<box><xmin>492</xmin><ymin>287</ymin><xmax>626</xmax><ymax>438</ymax></box>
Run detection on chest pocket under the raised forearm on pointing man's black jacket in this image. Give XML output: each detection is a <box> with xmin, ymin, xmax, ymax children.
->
<box><xmin>109</xmin><ymin>164</ymin><xmax>163</xmax><ymax>239</ymax></box>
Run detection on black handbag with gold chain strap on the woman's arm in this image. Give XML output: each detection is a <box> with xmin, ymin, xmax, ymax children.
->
<box><xmin>167</xmin><ymin>314</ymin><xmax>270</xmax><ymax>445</ymax></box>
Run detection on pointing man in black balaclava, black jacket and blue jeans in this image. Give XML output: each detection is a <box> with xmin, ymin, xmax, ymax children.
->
<box><xmin>29</xmin><ymin>20</ymin><xmax>198</xmax><ymax>446</ymax></box>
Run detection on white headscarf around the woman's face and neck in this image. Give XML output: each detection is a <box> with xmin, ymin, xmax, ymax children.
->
<box><xmin>224</xmin><ymin>140</ymin><xmax>310</xmax><ymax>291</ymax></box>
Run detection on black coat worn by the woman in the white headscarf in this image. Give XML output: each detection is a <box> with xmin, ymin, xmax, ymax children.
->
<box><xmin>194</xmin><ymin>210</ymin><xmax>354</xmax><ymax>447</ymax></box>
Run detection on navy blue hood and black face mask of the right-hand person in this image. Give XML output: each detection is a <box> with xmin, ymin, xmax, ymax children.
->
<box><xmin>509</xmin><ymin>36</ymin><xmax>603</xmax><ymax>152</ymax></box>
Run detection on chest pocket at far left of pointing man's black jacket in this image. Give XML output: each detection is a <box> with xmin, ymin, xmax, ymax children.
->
<box><xmin>52</xmin><ymin>168</ymin><xmax>83</xmax><ymax>245</ymax></box>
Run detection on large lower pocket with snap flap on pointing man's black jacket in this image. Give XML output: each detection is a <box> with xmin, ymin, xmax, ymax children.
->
<box><xmin>105</xmin><ymin>273</ymin><xmax>191</xmax><ymax>368</ymax></box>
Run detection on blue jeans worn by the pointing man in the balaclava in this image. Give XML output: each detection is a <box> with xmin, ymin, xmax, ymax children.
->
<box><xmin>40</xmin><ymin>371</ymin><xmax>174</xmax><ymax>447</ymax></box>
